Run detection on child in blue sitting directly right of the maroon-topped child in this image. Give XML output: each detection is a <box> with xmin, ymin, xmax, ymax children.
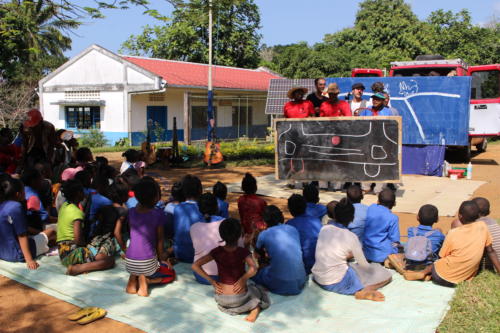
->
<box><xmin>252</xmin><ymin>205</ymin><xmax>307</xmax><ymax>295</ymax></box>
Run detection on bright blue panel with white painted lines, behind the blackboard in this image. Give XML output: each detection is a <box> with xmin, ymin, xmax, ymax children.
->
<box><xmin>326</xmin><ymin>76</ymin><xmax>471</xmax><ymax>146</ymax></box>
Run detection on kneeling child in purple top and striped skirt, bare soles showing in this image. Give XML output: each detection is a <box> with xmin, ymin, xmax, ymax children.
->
<box><xmin>125</xmin><ymin>179</ymin><xmax>175</xmax><ymax>297</ymax></box>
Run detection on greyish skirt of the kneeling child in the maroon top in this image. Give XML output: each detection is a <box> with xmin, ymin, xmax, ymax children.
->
<box><xmin>215</xmin><ymin>282</ymin><xmax>271</xmax><ymax>316</ymax></box>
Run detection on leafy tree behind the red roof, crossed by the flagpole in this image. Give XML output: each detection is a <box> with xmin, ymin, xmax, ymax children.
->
<box><xmin>121</xmin><ymin>0</ymin><xmax>261</xmax><ymax>68</ymax></box>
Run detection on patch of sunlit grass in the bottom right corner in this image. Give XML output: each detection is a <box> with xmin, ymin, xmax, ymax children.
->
<box><xmin>437</xmin><ymin>271</ymin><xmax>500</xmax><ymax>333</ymax></box>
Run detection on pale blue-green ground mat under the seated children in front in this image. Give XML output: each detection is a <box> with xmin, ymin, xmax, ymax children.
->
<box><xmin>0</xmin><ymin>257</ymin><xmax>454</xmax><ymax>333</ymax></box>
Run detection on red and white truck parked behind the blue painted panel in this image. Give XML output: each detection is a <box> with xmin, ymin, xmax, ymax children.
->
<box><xmin>351</xmin><ymin>55</ymin><xmax>500</xmax><ymax>161</ymax></box>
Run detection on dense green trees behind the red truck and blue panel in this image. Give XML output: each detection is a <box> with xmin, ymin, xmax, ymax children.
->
<box><xmin>260</xmin><ymin>0</ymin><xmax>500</xmax><ymax>78</ymax></box>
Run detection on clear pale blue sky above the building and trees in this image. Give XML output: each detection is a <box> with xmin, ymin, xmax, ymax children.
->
<box><xmin>65</xmin><ymin>0</ymin><xmax>500</xmax><ymax>57</ymax></box>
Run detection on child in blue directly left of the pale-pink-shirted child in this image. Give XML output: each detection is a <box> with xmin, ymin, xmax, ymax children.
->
<box><xmin>174</xmin><ymin>175</ymin><xmax>203</xmax><ymax>263</ymax></box>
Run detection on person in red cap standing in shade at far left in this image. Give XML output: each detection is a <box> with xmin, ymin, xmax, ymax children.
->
<box><xmin>20</xmin><ymin>109</ymin><xmax>56</xmax><ymax>167</ymax></box>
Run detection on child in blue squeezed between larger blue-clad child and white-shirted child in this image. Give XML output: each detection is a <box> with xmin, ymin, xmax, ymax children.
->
<box><xmin>287</xmin><ymin>194</ymin><xmax>321</xmax><ymax>274</ymax></box>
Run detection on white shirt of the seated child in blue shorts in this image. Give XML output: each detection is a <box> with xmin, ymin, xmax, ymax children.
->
<box><xmin>311</xmin><ymin>224</ymin><xmax>369</xmax><ymax>285</ymax></box>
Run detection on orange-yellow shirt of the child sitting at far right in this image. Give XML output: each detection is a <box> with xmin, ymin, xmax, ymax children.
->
<box><xmin>434</xmin><ymin>221</ymin><xmax>491</xmax><ymax>283</ymax></box>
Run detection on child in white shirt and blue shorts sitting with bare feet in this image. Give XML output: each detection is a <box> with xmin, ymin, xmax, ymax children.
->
<box><xmin>312</xmin><ymin>198</ymin><xmax>391</xmax><ymax>301</ymax></box>
